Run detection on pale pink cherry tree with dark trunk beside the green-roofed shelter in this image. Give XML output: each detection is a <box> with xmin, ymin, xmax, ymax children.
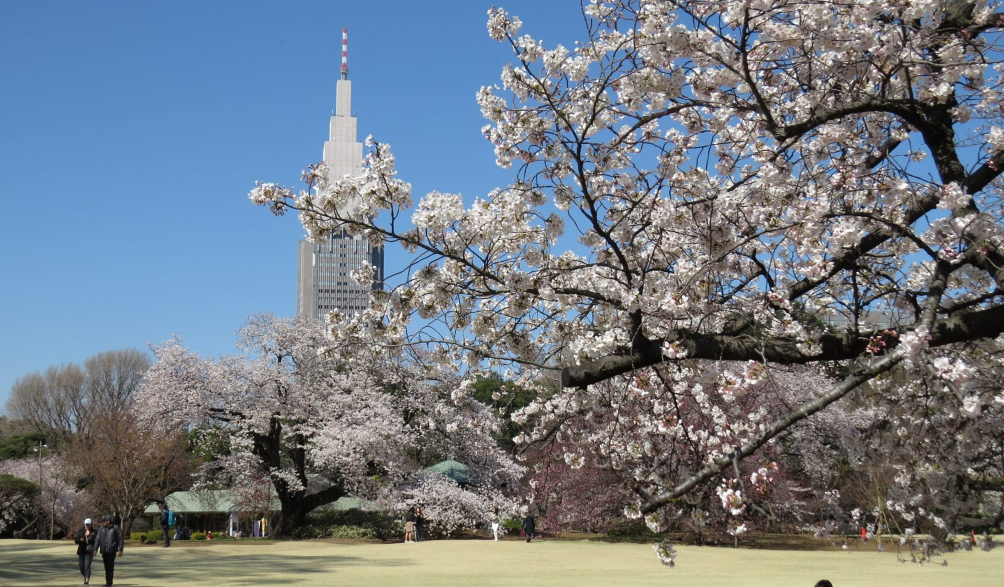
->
<box><xmin>138</xmin><ymin>315</ymin><xmax>521</xmax><ymax>534</ymax></box>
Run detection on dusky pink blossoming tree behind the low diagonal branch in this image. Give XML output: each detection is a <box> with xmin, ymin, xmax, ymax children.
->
<box><xmin>514</xmin><ymin>361</ymin><xmax>843</xmax><ymax>542</ymax></box>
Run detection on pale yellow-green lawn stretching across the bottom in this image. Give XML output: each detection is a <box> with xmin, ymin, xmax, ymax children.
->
<box><xmin>0</xmin><ymin>540</ymin><xmax>1004</xmax><ymax>587</ymax></box>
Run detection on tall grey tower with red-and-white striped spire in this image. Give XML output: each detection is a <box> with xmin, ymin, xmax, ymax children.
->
<box><xmin>296</xmin><ymin>28</ymin><xmax>384</xmax><ymax>318</ymax></box>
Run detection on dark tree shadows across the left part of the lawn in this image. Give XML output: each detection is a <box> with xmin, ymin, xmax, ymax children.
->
<box><xmin>0</xmin><ymin>541</ymin><xmax>411</xmax><ymax>587</ymax></box>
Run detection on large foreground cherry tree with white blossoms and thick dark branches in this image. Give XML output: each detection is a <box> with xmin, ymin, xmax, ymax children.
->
<box><xmin>250</xmin><ymin>0</ymin><xmax>1004</xmax><ymax>549</ymax></box>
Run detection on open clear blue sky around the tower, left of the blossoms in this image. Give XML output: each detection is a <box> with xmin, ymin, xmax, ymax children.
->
<box><xmin>0</xmin><ymin>0</ymin><xmax>584</xmax><ymax>411</ymax></box>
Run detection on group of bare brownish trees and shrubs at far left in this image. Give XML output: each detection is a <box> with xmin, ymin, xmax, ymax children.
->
<box><xmin>0</xmin><ymin>349</ymin><xmax>193</xmax><ymax>538</ymax></box>
